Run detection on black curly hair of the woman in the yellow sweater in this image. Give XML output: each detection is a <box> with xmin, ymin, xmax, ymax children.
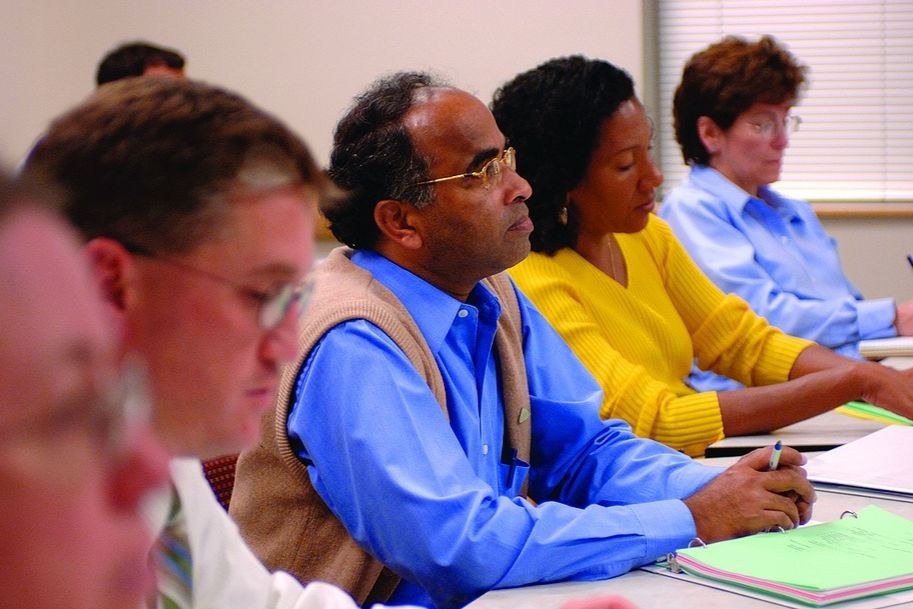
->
<box><xmin>491</xmin><ymin>55</ymin><xmax>634</xmax><ymax>254</ymax></box>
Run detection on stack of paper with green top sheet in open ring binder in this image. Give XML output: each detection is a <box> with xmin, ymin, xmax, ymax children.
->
<box><xmin>675</xmin><ymin>506</ymin><xmax>913</xmax><ymax>606</ymax></box>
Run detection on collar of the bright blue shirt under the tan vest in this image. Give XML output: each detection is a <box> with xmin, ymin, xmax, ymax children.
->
<box><xmin>352</xmin><ymin>250</ymin><xmax>500</xmax><ymax>353</ymax></box>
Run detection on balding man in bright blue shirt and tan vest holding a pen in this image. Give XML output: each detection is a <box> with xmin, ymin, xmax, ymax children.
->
<box><xmin>232</xmin><ymin>73</ymin><xmax>814</xmax><ymax>607</ymax></box>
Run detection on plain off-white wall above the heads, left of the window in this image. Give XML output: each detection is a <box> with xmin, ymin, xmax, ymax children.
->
<box><xmin>0</xmin><ymin>0</ymin><xmax>643</xmax><ymax>164</ymax></box>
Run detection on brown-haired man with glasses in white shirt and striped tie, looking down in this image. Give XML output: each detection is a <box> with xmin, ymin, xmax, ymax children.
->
<box><xmin>25</xmin><ymin>78</ymin><xmax>414</xmax><ymax>609</ymax></box>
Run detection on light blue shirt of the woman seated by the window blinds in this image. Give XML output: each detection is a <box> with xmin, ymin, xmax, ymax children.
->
<box><xmin>659</xmin><ymin>165</ymin><xmax>896</xmax><ymax>391</ymax></box>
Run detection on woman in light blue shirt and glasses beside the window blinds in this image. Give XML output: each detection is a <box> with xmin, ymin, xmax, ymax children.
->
<box><xmin>659</xmin><ymin>36</ymin><xmax>913</xmax><ymax>390</ymax></box>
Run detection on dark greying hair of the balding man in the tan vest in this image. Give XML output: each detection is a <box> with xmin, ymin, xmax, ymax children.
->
<box><xmin>321</xmin><ymin>72</ymin><xmax>449</xmax><ymax>249</ymax></box>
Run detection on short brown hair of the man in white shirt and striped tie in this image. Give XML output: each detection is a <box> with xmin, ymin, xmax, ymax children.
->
<box><xmin>25</xmin><ymin>78</ymin><xmax>328</xmax><ymax>253</ymax></box>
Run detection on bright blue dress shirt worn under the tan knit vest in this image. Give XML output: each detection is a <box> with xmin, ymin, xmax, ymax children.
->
<box><xmin>288</xmin><ymin>251</ymin><xmax>720</xmax><ymax>607</ymax></box>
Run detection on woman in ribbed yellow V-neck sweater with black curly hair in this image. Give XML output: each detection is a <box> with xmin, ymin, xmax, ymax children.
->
<box><xmin>492</xmin><ymin>56</ymin><xmax>913</xmax><ymax>455</ymax></box>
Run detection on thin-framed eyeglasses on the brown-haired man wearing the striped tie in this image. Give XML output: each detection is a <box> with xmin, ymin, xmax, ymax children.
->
<box><xmin>121</xmin><ymin>241</ymin><xmax>312</xmax><ymax>330</ymax></box>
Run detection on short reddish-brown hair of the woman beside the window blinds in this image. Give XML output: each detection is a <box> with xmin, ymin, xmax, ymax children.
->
<box><xmin>672</xmin><ymin>36</ymin><xmax>808</xmax><ymax>165</ymax></box>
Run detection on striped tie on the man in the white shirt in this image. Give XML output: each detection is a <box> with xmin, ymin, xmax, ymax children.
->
<box><xmin>154</xmin><ymin>492</ymin><xmax>193</xmax><ymax>609</ymax></box>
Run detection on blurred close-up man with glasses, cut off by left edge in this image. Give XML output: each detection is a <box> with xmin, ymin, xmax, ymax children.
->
<box><xmin>0</xmin><ymin>172</ymin><xmax>167</xmax><ymax>609</ymax></box>
